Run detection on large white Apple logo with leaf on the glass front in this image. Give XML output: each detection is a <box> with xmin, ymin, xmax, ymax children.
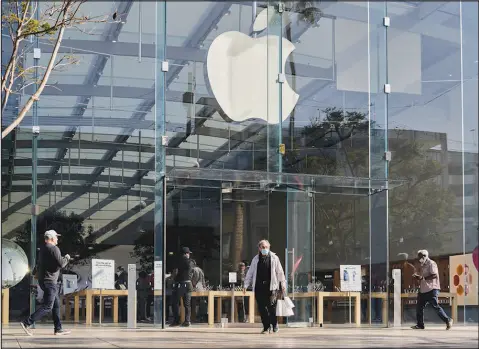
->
<box><xmin>206</xmin><ymin>9</ymin><xmax>299</xmax><ymax>124</ymax></box>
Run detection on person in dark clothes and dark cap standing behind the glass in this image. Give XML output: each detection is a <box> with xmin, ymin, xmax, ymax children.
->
<box><xmin>170</xmin><ymin>247</ymin><xmax>195</xmax><ymax>327</ymax></box>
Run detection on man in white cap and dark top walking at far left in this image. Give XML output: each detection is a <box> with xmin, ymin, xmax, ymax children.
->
<box><xmin>20</xmin><ymin>230</ymin><xmax>70</xmax><ymax>336</ymax></box>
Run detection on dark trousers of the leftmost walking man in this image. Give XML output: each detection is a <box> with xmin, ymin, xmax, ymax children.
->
<box><xmin>24</xmin><ymin>281</ymin><xmax>62</xmax><ymax>331</ymax></box>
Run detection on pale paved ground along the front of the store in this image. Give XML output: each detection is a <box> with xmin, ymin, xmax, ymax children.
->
<box><xmin>2</xmin><ymin>324</ymin><xmax>478</xmax><ymax>348</ymax></box>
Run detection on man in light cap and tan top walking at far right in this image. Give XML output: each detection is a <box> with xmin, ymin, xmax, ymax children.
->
<box><xmin>411</xmin><ymin>250</ymin><xmax>453</xmax><ymax>330</ymax></box>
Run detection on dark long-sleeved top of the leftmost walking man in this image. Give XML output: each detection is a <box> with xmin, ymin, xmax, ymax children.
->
<box><xmin>36</xmin><ymin>243</ymin><xmax>68</xmax><ymax>284</ymax></box>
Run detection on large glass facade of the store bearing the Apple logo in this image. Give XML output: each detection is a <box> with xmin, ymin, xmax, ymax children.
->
<box><xmin>2</xmin><ymin>1</ymin><xmax>479</xmax><ymax>326</ymax></box>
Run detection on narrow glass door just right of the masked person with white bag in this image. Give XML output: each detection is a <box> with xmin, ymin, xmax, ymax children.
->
<box><xmin>285</xmin><ymin>189</ymin><xmax>316</xmax><ymax>326</ymax></box>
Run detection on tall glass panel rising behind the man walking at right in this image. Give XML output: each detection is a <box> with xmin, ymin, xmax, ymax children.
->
<box><xmin>387</xmin><ymin>2</ymin><xmax>466</xmax><ymax>326</ymax></box>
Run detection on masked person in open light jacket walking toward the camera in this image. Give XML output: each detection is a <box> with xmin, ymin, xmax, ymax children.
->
<box><xmin>243</xmin><ymin>240</ymin><xmax>286</xmax><ymax>334</ymax></box>
